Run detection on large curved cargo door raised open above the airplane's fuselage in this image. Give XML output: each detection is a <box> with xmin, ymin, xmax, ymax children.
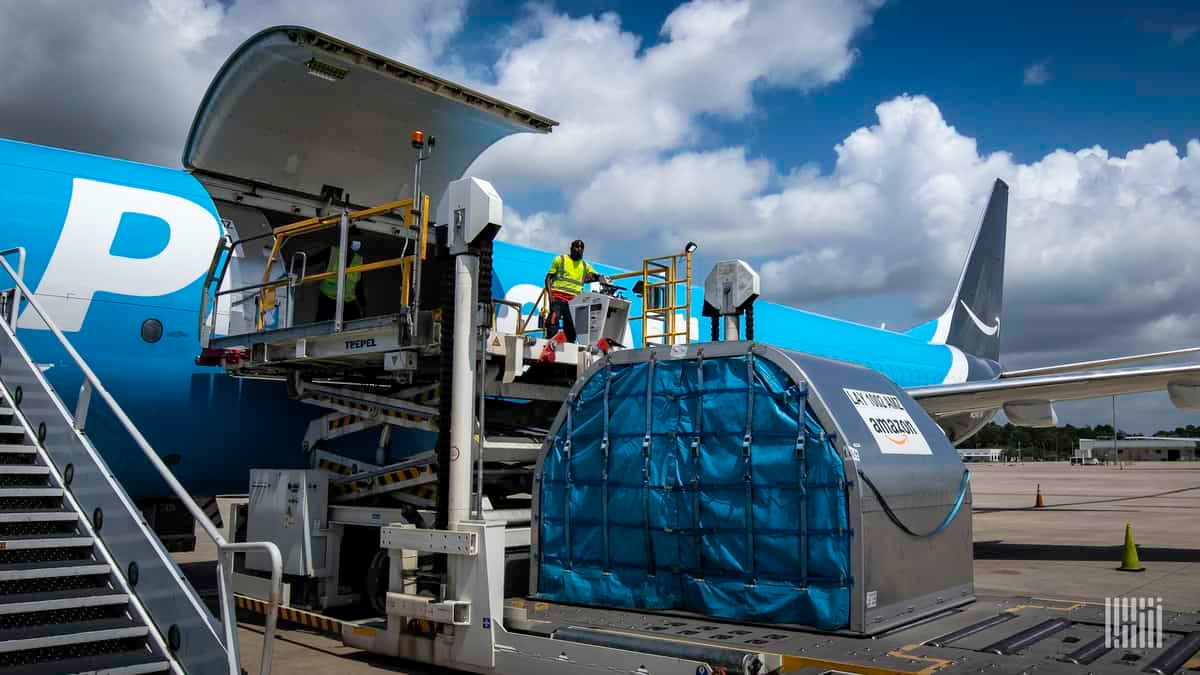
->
<box><xmin>184</xmin><ymin>26</ymin><xmax>558</xmax><ymax>213</ymax></box>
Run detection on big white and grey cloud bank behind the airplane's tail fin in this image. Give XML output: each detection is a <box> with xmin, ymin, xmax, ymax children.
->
<box><xmin>552</xmin><ymin>96</ymin><xmax>1200</xmax><ymax>365</ymax></box>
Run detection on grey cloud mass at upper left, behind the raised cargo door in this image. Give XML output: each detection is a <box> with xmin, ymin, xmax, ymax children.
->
<box><xmin>0</xmin><ymin>0</ymin><xmax>466</xmax><ymax>166</ymax></box>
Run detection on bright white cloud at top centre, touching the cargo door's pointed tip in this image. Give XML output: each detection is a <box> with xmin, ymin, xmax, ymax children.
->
<box><xmin>475</xmin><ymin>0</ymin><xmax>880</xmax><ymax>187</ymax></box>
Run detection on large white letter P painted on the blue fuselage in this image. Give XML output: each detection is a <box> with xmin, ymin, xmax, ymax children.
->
<box><xmin>18</xmin><ymin>178</ymin><xmax>220</xmax><ymax>333</ymax></box>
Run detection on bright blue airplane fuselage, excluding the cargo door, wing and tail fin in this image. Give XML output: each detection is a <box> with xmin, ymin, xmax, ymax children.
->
<box><xmin>0</xmin><ymin>139</ymin><xmax>1000</xmax><ymax>497</ymax></box>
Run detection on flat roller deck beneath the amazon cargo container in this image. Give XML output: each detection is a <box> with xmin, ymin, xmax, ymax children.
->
<box><xmin>505</xmin><ymin>597</ymin><xmax>1200</xmax><ymax>675</ymax></box>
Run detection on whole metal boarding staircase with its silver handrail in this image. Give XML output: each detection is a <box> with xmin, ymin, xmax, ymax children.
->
<box><xmin>0</xmin><ymin>250</ymin><xmax>282</xmax><ymax>675</ymax></box>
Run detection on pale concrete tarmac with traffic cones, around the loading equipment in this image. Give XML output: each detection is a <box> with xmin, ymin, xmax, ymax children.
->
<box><xmin>171</xmin><ymin>462</ymin><xmax>1200</xmax><ymax>675</ymax></box>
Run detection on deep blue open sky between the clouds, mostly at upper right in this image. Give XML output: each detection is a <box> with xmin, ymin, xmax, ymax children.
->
<box><xmin>455</xmin><ymin>0</ymin><xmax>1200</xmax><ymax>210</ymax></box>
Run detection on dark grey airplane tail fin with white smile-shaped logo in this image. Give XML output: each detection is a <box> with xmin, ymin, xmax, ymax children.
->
<box><xmin>916</xmin><ymin>179</ymin><xmax>1008</xmax><ymax>362</ymax></box>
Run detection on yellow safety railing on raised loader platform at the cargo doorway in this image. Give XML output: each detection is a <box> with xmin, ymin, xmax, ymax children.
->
<box><xmin>256</xmin><ymin>195</ymin><xmax>430</xmax><ymax>330</ymax></box>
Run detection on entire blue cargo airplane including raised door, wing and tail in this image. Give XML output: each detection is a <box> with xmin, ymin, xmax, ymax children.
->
<box><xmin>0</xmin><ymin>26</ymin><xmax>1200</xmax><ymax>498</ymax></box>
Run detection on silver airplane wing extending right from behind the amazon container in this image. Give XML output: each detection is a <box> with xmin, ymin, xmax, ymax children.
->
<box><xmin>907</xmin><ymin>364</ymin><xmax>1200</xmax><ymax>423</ymax></box>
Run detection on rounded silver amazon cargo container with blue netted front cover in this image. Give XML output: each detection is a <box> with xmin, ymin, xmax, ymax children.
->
<box><xmin>530</xmin><ymin>342</ymin><xmax>974</xmax><ymax>634</ymax></box>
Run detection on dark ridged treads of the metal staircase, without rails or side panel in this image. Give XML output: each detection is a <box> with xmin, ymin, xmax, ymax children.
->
<box><xmin>0</xmin><ymin>401</ymin><xmax>172</xmax><ymax>675</ymax></box>
